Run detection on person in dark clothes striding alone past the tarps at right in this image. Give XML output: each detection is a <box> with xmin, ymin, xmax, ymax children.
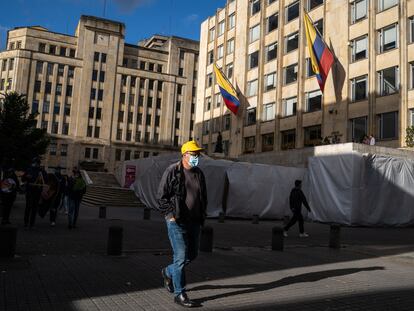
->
<box><xmin>283</xmin><ymin>180</ymin><xmax>311</xmax><ymax>238</ymax></box>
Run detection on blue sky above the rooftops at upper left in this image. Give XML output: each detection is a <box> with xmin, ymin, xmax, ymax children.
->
<box><xmin>0</xmin><ymin>0</ymin><xmax>226</xmax><ymax>49</ymax></box>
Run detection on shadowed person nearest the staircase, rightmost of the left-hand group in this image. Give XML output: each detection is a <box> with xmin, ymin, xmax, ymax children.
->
<box><xmin>68</xmin><ymin>169</ymin><xmax>86</xmax><ymax>229</ymax></box>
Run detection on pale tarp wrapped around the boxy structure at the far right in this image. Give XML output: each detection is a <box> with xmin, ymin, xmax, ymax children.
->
<box><xmin>309</xmin><ymin>153</ymin><xmax>414</xmax><ymax>226</ymax></box>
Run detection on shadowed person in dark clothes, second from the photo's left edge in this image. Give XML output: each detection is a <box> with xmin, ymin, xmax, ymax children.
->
<box><xmin>22</xmin><ymin>157</ymin><xmax>47</xmax><ymax>228</ymax></box>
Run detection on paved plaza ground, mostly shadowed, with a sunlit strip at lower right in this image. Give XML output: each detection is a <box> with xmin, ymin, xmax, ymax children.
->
<box><xmin>0</xmin><ymin>197</ymin><xmax>414</xmax><ymax>311</ymax></box>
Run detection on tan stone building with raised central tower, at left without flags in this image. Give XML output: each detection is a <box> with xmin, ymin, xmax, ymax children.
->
<box><xmin>0</xmin><ymin>16</ymin><xmax>199</xmax><ymax>171</ymax></box>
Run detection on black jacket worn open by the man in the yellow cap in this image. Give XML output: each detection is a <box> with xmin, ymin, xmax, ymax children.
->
<box><xmin>157</xmin><ymin>161</ymin><xmax>207</xmax><ymax>224</ymax></box>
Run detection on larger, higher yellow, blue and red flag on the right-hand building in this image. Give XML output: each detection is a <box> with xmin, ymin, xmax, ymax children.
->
<box><xmin>304</xmin><ymin>12</ymin><xmax>334</xmax><ymax>93</ymax></box>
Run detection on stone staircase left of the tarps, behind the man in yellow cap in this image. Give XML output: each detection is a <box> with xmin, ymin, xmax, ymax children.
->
<box><xmin>82</xmin><ymin>171</ymin><xmax>145</xmax><ymax>207</ymax></box>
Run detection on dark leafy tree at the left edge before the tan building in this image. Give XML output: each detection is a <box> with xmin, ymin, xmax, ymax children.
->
<box><xmin>0</xmin><ymin>92</ymin><xmax>49</xmax><ymax>169</ymax></box>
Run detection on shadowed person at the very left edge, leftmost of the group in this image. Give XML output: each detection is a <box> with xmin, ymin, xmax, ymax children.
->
<box><xmin>0</xmin><ymin>168</ymin><xmax>19</xmax><ymax>225</ymax></box>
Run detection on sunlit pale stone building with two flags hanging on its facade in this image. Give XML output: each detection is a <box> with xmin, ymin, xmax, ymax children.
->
<box><xmin>196</xmin><ymin>0</ymin><xmax>414</xmax><ymax>157</ymax></box>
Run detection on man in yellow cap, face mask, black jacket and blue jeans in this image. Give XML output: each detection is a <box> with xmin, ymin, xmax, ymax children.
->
<box><xmin>158</xmin><ymin>141</ymin><xmax>207</xmax><ymax>307</ymax></box>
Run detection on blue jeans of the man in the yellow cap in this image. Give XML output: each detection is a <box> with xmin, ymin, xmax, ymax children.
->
<box><xmin>166</xmin><ymin>220</ymin><xmax>200</xmax><ymax>296</ymax></box>
